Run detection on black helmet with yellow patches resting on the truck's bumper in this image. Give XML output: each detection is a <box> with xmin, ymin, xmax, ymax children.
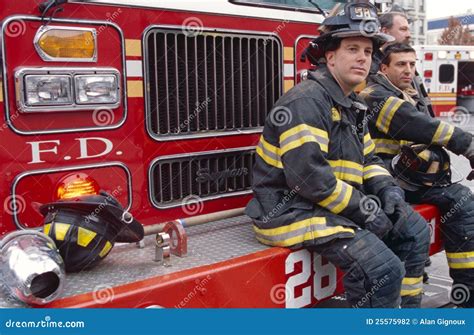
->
<box><xmin>40</xmin><ymin>192</ymin><xmax>144</xmax><ymax>272</ymax></box>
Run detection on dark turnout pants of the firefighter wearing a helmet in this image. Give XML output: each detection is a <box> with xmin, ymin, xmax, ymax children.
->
<box><xmin>311</xmin><ymin>205</ymin><xmax>429</xmax><ymax>308</ymax></box>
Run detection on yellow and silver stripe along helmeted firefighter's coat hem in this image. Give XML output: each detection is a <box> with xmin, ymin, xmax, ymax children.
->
<box><xmin>253</xmin><ymin>217</ymin><xmax>354</xmax><ymax>247</ymax></box>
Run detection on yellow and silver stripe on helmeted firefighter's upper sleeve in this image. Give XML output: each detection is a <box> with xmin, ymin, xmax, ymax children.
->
<box><xmin>280</xmin><ymin>124</ymin><xmax>329</xmax><ymax>156</ymax></box>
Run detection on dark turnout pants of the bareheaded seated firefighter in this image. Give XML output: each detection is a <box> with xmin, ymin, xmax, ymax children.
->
<box><xmin>406</xmin><ymin>184</ymin><xmax>474</xmax><ymax>308</ymax></box>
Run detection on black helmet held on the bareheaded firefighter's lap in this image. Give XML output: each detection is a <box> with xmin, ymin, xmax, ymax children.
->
<box><xmin>392</xmin><ymin>144</ymin><xmax>452</xmax><ymax>191</ymax></box>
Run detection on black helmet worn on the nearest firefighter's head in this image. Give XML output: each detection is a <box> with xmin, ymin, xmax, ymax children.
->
<box><xmin>305</xmin><ymin>2</ymin><xmax>394</xmax><ymax>65</ymax></box>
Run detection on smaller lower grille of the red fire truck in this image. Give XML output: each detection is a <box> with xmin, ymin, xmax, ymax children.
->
<box><xmin>150</xmin><ymin>148</ymin><xmax>255</xmax><ymax>208</ymax></box>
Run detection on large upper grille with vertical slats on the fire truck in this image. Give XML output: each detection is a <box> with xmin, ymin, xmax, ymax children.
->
<box><xmin>145</xmin><ymin>28</ymin><xmax>282</xmax><ymax>139</ymax></box>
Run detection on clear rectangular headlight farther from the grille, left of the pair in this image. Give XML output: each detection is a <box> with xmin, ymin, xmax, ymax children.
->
<box><xmin>24</xmin><ymin>75</ymin><xmax>73</xmax><ymax>106</ymax></box>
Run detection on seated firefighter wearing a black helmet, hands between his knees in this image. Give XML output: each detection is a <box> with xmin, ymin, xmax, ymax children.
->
<box><xmin>246</xmin><ymin>3</ymin><xmax>429</xmax><ymax>307</ymax></box>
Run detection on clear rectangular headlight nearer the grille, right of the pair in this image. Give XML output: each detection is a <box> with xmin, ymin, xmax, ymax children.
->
<box><xmin>74</xmin><ymin>74</ymin><xmax>119</xmax><ymax>104</ymax></box>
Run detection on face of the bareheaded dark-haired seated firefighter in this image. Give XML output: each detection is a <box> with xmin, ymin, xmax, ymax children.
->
<box><xmin>380</xmin><ymin>52</ymin><xmax>416</xmax><ymax>90</ymax></box>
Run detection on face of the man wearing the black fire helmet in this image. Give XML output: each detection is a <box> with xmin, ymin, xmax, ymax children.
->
<box><xmin>326</xmin><ymin>37</ymin><xmax>373</xmax><ymax>95</ymax></box>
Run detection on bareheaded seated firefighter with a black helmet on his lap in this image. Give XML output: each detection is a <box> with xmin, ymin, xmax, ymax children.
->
<box><xmin>361</xmin><ymin>43</ymin><xmax>474</xmax><ymax>307</ymax></box>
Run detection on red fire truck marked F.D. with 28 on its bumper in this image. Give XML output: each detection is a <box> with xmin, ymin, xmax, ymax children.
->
<box><xmin>0</xmin><ymin>0</ymin><xmax>441</xmax><ymax>308</ymax></box>
